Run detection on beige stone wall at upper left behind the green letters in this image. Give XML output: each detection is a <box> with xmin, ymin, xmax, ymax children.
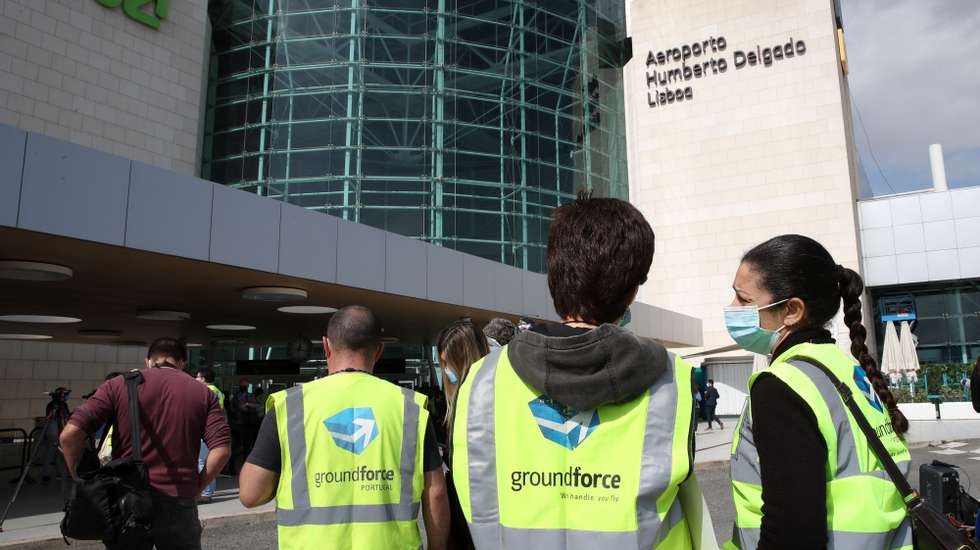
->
<box><xmin>0</xmin><ymin>0</ymin><xmax>209</xmax><ymax>174</ymax></box>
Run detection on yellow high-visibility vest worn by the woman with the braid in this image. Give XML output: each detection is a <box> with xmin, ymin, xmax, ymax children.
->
<box><xmin>726</xmin><ymin>343</ymin><xmax>912</xmax><ymax>550</ymax></box>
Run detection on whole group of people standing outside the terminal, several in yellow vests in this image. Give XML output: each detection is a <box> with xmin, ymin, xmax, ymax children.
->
<box><xmin>49</xmin><ymin>195</ymin><xmax>928</xmax><ymax>550</ymax></box>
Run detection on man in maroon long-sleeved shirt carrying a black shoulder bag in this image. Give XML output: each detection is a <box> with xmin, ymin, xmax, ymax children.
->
<box><xmin>61</xmin><ymin>338</ymin><xmax>231</xmax><ymax>550</ymax></box>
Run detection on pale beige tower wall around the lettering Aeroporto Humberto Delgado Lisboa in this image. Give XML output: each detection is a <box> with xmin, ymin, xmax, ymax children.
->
<box><xmin>626</xmin><ymin>0</ymin><xmax>860</xmax><ymax>347</ymax></box>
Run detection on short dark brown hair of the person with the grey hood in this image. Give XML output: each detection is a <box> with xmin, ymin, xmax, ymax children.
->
<box><xmin>547</xmin><ymin>192</ymin><xmax>654</xmax><ymax>325</ymax></box>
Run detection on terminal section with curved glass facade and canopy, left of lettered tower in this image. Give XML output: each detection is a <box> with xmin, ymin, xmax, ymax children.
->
<box><xmin>0</xmin><ymin>0</ymin><xmax>702</xmax><ymax>436</ymax></box>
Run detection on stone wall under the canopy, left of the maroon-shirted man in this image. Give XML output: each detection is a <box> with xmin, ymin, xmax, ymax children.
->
<box><xmin>0</xmin><ymin>340</ymin><xmax>146</xmax><ymax>432</ymax></box>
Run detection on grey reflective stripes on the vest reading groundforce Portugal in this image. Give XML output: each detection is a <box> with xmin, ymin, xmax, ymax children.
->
<box><xmin>276</xmin><ymin>386</ymin><xmax>420</xmax><ymax>527</ymax></box>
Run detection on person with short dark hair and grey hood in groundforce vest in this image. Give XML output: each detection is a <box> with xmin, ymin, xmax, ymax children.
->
<box><xmin>452</xmin><ymin>194</ymin><xmax>700</xmax><ymax>550</ymax></box>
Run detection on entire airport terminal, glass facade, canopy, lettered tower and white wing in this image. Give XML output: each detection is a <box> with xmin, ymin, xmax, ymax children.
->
<box><xmin>0</xmin><ymin>0</ymin><xmax>980</xmax><ymax>427</ymax></box>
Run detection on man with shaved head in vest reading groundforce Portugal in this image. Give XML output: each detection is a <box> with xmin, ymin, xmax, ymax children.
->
<box><xmin>239</xmin><ymin>306</ymin><xmax>449</xmax><ymax>550</ymax></box>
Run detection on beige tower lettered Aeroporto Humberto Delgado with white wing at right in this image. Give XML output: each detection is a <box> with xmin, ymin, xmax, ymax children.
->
<box><xmin>625</xmin><ymin>0</ymin><xmax>980</xmax><ymax>414</ymax></box>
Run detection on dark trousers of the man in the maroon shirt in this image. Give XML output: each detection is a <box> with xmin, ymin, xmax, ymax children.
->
<box><xmin>105</xmin><ymin>493</ymin><xmax>201</xmax><ymax>550</ymax></box>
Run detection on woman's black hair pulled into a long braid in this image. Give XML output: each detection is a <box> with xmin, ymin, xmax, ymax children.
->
<box><xmin>742</xmin><ymin>235</ymin><xmax>909</xmax><ymax>434</ymax></box>
